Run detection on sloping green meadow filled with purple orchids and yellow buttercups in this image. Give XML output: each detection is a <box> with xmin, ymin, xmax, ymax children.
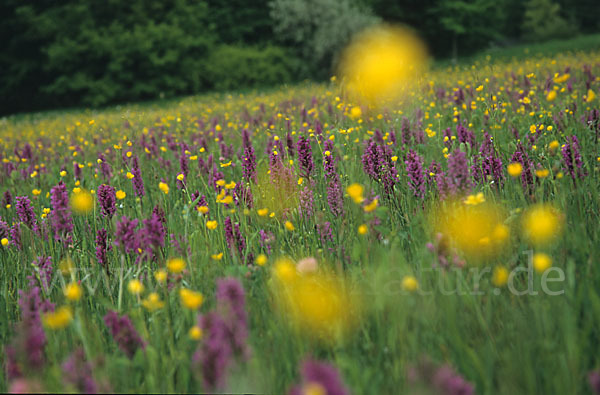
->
<box><xmin>0</xmin><ymin>41</ymin><xmax>600</xmax><ymax>395</ymax></box>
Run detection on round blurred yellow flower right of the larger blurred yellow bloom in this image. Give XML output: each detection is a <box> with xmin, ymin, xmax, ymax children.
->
<box><xmin>523</xmin><ymin>205</ymin><xmax>562</xmax><ymax>246</ymax></box>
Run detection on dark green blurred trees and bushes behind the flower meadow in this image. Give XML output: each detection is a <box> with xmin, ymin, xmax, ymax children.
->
<box><xmin>0</xmin><ymin>0</ymin><xmax>600</xmax><ymax>114</ymax></box>
